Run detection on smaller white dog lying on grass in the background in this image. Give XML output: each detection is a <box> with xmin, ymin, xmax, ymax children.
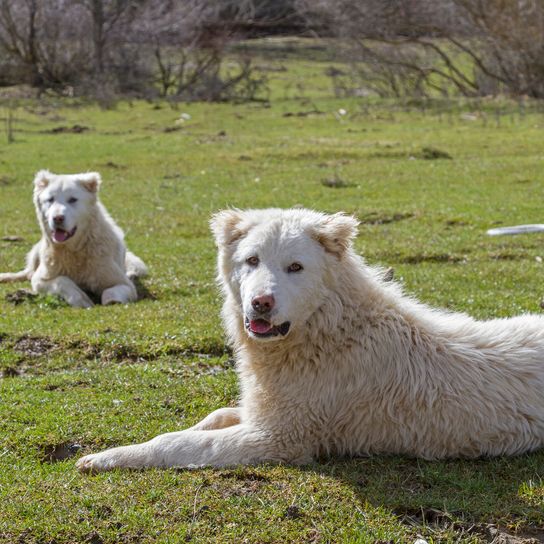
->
<box><xmin>0</xmin><ymin>170</ymin><xmax>147</xmax><ymax>308</ymax></box>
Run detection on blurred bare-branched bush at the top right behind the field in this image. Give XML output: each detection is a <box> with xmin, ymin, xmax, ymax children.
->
<box><xmin>298</xmin><ymin>0</ymin><xmax>544</xmax><ymax>98</ymax></box>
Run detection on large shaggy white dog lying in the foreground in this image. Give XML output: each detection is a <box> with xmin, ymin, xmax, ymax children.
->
<box><xmin>78</xmin><ymin>209</ymin><xmax>544</xmax><ymax>472</ymax></box>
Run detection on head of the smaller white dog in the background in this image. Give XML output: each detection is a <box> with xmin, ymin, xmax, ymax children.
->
<box><xmin>34</xmin><ymin>170</ymin><xmax>101</xmax><ymax>245</ymax></box>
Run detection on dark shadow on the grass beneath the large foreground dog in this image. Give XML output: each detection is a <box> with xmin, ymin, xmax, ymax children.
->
<box><xmin>304</xmin><ymin>451</ymin><xmax>544</xmax><ymax>544</ymax></box>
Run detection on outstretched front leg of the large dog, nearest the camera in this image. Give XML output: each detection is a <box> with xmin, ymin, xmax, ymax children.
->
<box><xmin>76</xmin><ymin>424</ymin><xmax>302</xmax><ymax>472</ymax></box>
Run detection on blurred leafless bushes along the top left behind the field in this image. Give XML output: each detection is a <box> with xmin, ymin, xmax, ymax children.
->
<box><xmin>0</xmin><ymin>0</ymin><xmax>266</xmax><ymax>103</ymax></box>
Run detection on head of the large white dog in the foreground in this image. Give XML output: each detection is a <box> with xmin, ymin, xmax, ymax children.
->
<box><xmin>211</xmin><ymin>209</ymin><xmax>358</xmax><ymax>341</ymax></box>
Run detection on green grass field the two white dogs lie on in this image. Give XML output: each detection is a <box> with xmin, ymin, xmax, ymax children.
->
<box><xmin>0</xmin><ymin>42</ymin><xmax>544</xmax><ymax>544</ymax></box>
